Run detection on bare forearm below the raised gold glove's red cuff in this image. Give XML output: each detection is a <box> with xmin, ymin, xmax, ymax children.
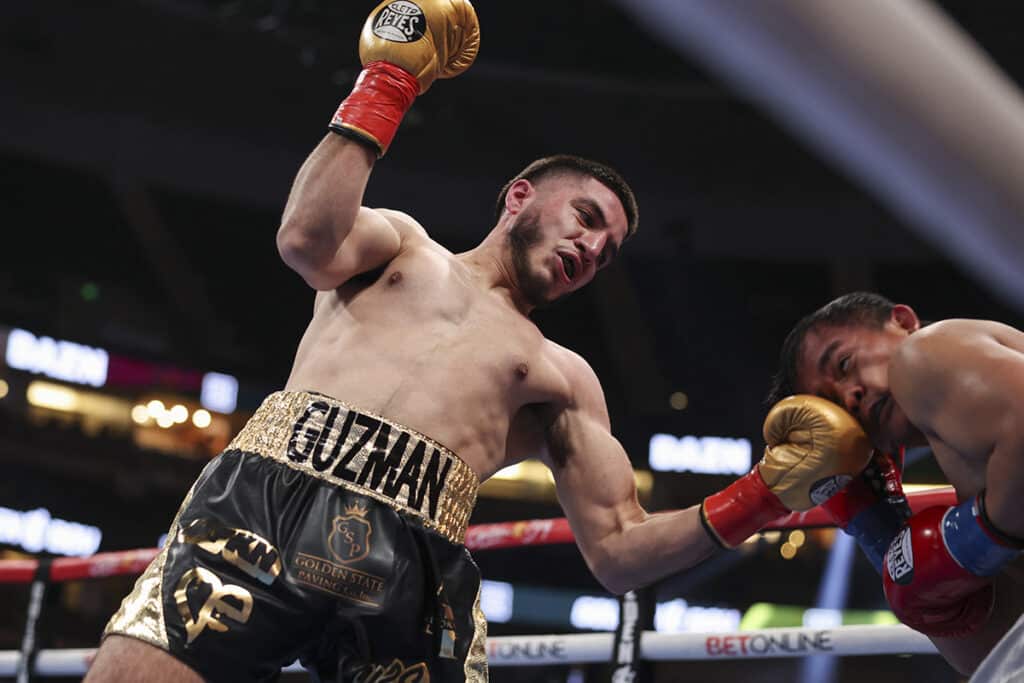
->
<box><xmin>278</xmin><ymin>133</ymin><xmax>377</xmax><ymax>267</ymax></box>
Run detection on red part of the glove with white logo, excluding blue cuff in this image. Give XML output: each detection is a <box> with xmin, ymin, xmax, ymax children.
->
<box><xmin>882</xmin><ymin>501</ymin><xmax>994</xmax><ymax>637</ymax></box>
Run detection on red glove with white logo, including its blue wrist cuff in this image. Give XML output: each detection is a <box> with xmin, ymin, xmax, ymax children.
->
<box><xmin>882</xmin><ymin>490</ymin><xmax>1024</xmax><ymax>637</ymax></box>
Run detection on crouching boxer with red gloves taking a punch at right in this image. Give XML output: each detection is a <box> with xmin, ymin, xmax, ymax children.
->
<box><xmin>769</xmin><ymin>293</ymin><xmax>1024</xmax><ymax>673</ymax></box>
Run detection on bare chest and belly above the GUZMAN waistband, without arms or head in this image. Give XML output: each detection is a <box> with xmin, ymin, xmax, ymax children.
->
<box><xmin>286</xmin><ymin>211</ymin><xmax>578</xmax><ymax>479</ymax></box>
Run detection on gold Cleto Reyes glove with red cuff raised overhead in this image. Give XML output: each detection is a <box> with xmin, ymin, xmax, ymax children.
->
<box><xmin>330</xmin><ymin>0</ymin><xmax>480</xmax><ymax>157</ymax></box>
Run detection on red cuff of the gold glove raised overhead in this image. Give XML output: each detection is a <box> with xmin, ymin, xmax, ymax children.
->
<box><xmin>330</xmin><ymin>61</ymin><xmax>420</xmax><ymax>157</ymax></box>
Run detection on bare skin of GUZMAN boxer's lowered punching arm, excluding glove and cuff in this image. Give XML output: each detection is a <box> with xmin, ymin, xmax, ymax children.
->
<box><xmin>542</xmin><ymin>353</ymin><xmax>718</xmax><ymax>594</ymax></box>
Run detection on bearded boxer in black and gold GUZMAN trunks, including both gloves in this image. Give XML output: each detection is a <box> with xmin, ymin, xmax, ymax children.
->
<box><xmin>89</xmin><ymin>0</ymin><xmax>870</xmax><ymax>681</ymax></box>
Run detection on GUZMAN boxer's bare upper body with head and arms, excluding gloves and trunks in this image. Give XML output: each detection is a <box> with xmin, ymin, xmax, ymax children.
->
<box><xmin>278</xmin><ymin>140</ymin><xmax>717</xmax><ymax>592</ymax></box>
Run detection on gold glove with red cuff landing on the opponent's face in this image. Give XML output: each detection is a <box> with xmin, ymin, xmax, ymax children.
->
<box><xmin>700</xmin><ymin>395</ymin><xmax>871</xmax><ymax>548</ymax></box>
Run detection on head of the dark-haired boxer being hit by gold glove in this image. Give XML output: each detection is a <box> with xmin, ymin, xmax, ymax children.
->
<box><xmin>768</xmin><ymin>292</ymin><xmax>921</xmax><ymax>452</ymax></box>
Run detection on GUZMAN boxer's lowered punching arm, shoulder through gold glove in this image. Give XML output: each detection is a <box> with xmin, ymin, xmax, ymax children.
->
<box><xmin>545</xmin><ymin>349</ymin><xmax>871</xmax><ymax>592</ymax></box>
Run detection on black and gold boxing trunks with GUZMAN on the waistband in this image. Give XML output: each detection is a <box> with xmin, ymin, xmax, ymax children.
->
<box><xmin>104</xmin><ymin>392</ymin><xmax>487</xmax><ymax>683</ymax></box>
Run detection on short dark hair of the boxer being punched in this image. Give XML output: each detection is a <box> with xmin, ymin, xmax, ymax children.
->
<box><xmin>765</xmin><ymin>292</ymin><xmax>896</xmax><ymax>405</ymax></box>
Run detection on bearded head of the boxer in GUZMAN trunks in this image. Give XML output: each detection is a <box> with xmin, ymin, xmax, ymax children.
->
<box><xmin>497</xmin><ymin>155</ymin><xmax>638</xmax><ymax>306</ymax></box>
